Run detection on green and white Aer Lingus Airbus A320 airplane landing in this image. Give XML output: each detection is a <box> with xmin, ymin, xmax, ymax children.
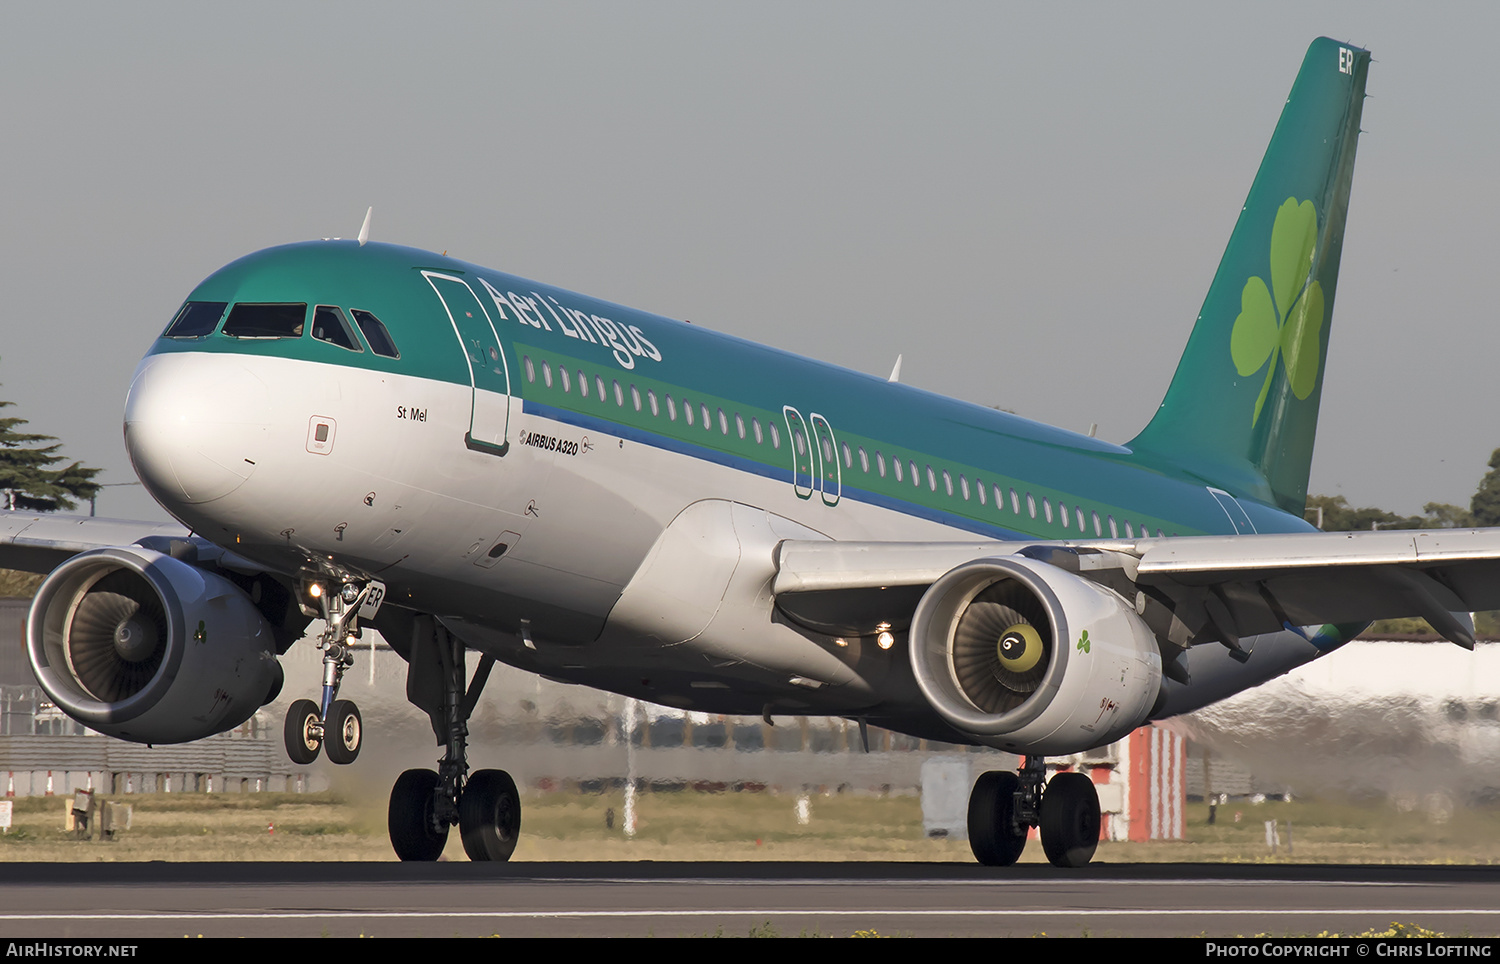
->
<box><xmin>0</xmin><ymin>39</ymin><xmax>1500</xmax><ymax>867</ymax></box>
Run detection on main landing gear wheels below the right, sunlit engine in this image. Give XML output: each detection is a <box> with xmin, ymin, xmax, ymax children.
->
<box><xmin>969</xmin><ymin>757</ymin><xmax>1100</xmax><ymax>867</ymax></box>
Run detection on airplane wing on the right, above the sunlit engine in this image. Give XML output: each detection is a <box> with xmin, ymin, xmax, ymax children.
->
<box><xmin>773</xmin><ymin>529</ymin><xmax>1500</xmax><ymax>649</ymax></box>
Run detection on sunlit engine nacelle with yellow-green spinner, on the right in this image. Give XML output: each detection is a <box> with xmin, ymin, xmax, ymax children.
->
<box><xmin>911</xmin><ymin>556</ymin><xmax>1161</xmax><ymax>754</ymax></box>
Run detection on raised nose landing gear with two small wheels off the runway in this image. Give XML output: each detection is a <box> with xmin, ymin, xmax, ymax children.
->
<box><xmin>282</xmin><ymin>582</ymin><xmax>386</xmax><ymax>765</ymax></box>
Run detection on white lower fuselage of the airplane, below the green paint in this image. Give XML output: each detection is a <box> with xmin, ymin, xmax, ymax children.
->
<box><xmin>126</xmin><ymin>352</ymin><xmax>1317</xmax><ymax>731</ymax></box>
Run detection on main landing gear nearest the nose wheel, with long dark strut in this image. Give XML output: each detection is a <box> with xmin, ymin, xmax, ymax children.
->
<box><xmin>389</xmin><ymin>616</ymin><xmax>521</xmax><ymax>861</ymax></box>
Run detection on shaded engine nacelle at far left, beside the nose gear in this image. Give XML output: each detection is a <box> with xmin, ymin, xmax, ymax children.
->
<box><xmin>27</xmin><ymin>546</ymin><xmax>282</xmax><ymax>744</ymax></box>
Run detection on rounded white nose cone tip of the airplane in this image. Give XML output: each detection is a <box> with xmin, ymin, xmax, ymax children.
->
<box><xmin>125</xmin><ymin>352</ymin><xmax>270</xmax><ymax>507</ymax></box>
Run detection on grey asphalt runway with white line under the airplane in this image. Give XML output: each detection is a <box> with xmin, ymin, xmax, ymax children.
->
<box><xmin>0</xmin><ymin>862</ymin><xmax>1500</xmax><ymax>939</ymax></box>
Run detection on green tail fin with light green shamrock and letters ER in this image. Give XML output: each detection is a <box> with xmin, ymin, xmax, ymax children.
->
<box><xmin>1130</xmin><ymin>37</ymin><xmax>1370</xmax><ymax>513</ymax></box>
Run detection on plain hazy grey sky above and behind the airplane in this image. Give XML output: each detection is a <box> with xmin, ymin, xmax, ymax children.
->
<box><xmin>0</xmin><ymin>0</ymin><xmax>1500</xmax><ymax>519</ymax></box>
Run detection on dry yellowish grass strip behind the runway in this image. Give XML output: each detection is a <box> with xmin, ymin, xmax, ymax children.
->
<box><xmin>0</xmin><ymin>792</ymin><xmax>1500</xmax><ymax>864</ymax></box>
